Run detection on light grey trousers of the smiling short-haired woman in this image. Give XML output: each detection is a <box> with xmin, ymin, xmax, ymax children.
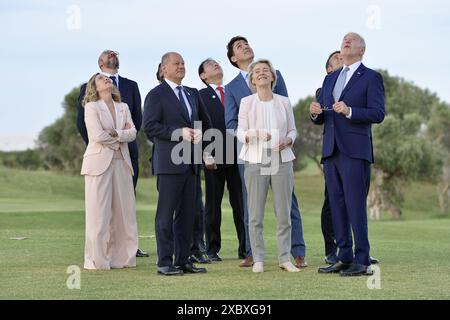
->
<box><xmin>245</xmin><ymin>153</ymin><xmax>294</xmax><ymax>263</ymax></box>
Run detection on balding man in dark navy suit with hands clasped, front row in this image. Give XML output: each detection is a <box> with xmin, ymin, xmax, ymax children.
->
<box><xmin>144</xmin><ymin>52</ymin><xmax>210</xmax><ymax>276</ymax></box>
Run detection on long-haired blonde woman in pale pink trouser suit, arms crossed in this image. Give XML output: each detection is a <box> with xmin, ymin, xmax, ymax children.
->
<box><xmin>81</xmin><ymin>73</ymin><xmax>138</xmax><ymax>270</ymax></box>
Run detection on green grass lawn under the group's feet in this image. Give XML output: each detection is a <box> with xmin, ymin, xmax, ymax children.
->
<box><xmin>0</xmin><ymin>167</ymin><xmax>450</xmax><ymax>299</ymax></box>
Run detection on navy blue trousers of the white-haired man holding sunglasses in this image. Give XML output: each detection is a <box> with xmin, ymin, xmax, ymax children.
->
<box><xmin>324</xmin><ymin>150</ymin><xmax>370</xmax><ymax>266</ymax></box>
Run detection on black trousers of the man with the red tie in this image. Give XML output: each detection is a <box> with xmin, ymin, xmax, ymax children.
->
<box><xmin>205</xmin><ymin>165</ymin><xmax>245</xmax><ymax>259</ymax></box>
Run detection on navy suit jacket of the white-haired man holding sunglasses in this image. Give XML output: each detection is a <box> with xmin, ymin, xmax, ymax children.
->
<box><xmin>312</xmin><ymin>63</ymin><xmax>385</xmax><ymax>163</ymax></box>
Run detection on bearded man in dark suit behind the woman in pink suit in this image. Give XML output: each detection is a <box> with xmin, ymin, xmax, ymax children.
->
<box><xmin>77</xmin><ymin>50</ymin><xmax>148</xmax><ymax>257</ymax></box>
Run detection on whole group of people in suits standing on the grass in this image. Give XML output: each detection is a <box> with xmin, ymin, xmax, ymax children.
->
<box><xmin>77</xmin><ymin>33</ymin><xmax>384</xmax><ymax>276</ymax></box>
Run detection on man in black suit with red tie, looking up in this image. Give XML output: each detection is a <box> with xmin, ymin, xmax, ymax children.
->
<box><xmin>198</xmin><ymin>59</ymin><xmax>245</xmax><ymax>261</ymax></box>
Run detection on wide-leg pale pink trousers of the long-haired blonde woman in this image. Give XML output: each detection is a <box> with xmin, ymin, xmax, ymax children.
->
<box><xmin>84</xmin><ymin>159</ymin><xmax>138</xmax><ymax>270</ymax></box>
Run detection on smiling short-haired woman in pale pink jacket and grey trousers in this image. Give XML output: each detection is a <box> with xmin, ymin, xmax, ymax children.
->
<box><xmin>237</xmin><ymin>60</ymin><xmax>300</xmax><ymax>272</ymax></box>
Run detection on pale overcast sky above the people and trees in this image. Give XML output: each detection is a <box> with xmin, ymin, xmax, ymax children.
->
<box><xmin>0</xmin><ymin>0</ymin><xmax>450</xmax><ymax>150</ymax></box>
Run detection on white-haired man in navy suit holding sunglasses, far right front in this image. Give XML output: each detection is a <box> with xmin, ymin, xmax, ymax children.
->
<box><xmin>310</xmin><ymin>33</ymin><xmax>385</xmax><ymax>276</ymax></box>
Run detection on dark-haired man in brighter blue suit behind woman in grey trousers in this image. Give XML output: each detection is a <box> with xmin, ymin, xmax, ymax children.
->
<box><xmin>225</xmin><ymin>36</ymin><xmax>308</xmax><ymax>268</ymax></box>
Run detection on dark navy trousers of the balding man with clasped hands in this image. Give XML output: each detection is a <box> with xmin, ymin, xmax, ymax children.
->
<box><xmin>155</xmin><ymin>170</ymin><xmax>198</xmax><ymax>267</ymax></box>
